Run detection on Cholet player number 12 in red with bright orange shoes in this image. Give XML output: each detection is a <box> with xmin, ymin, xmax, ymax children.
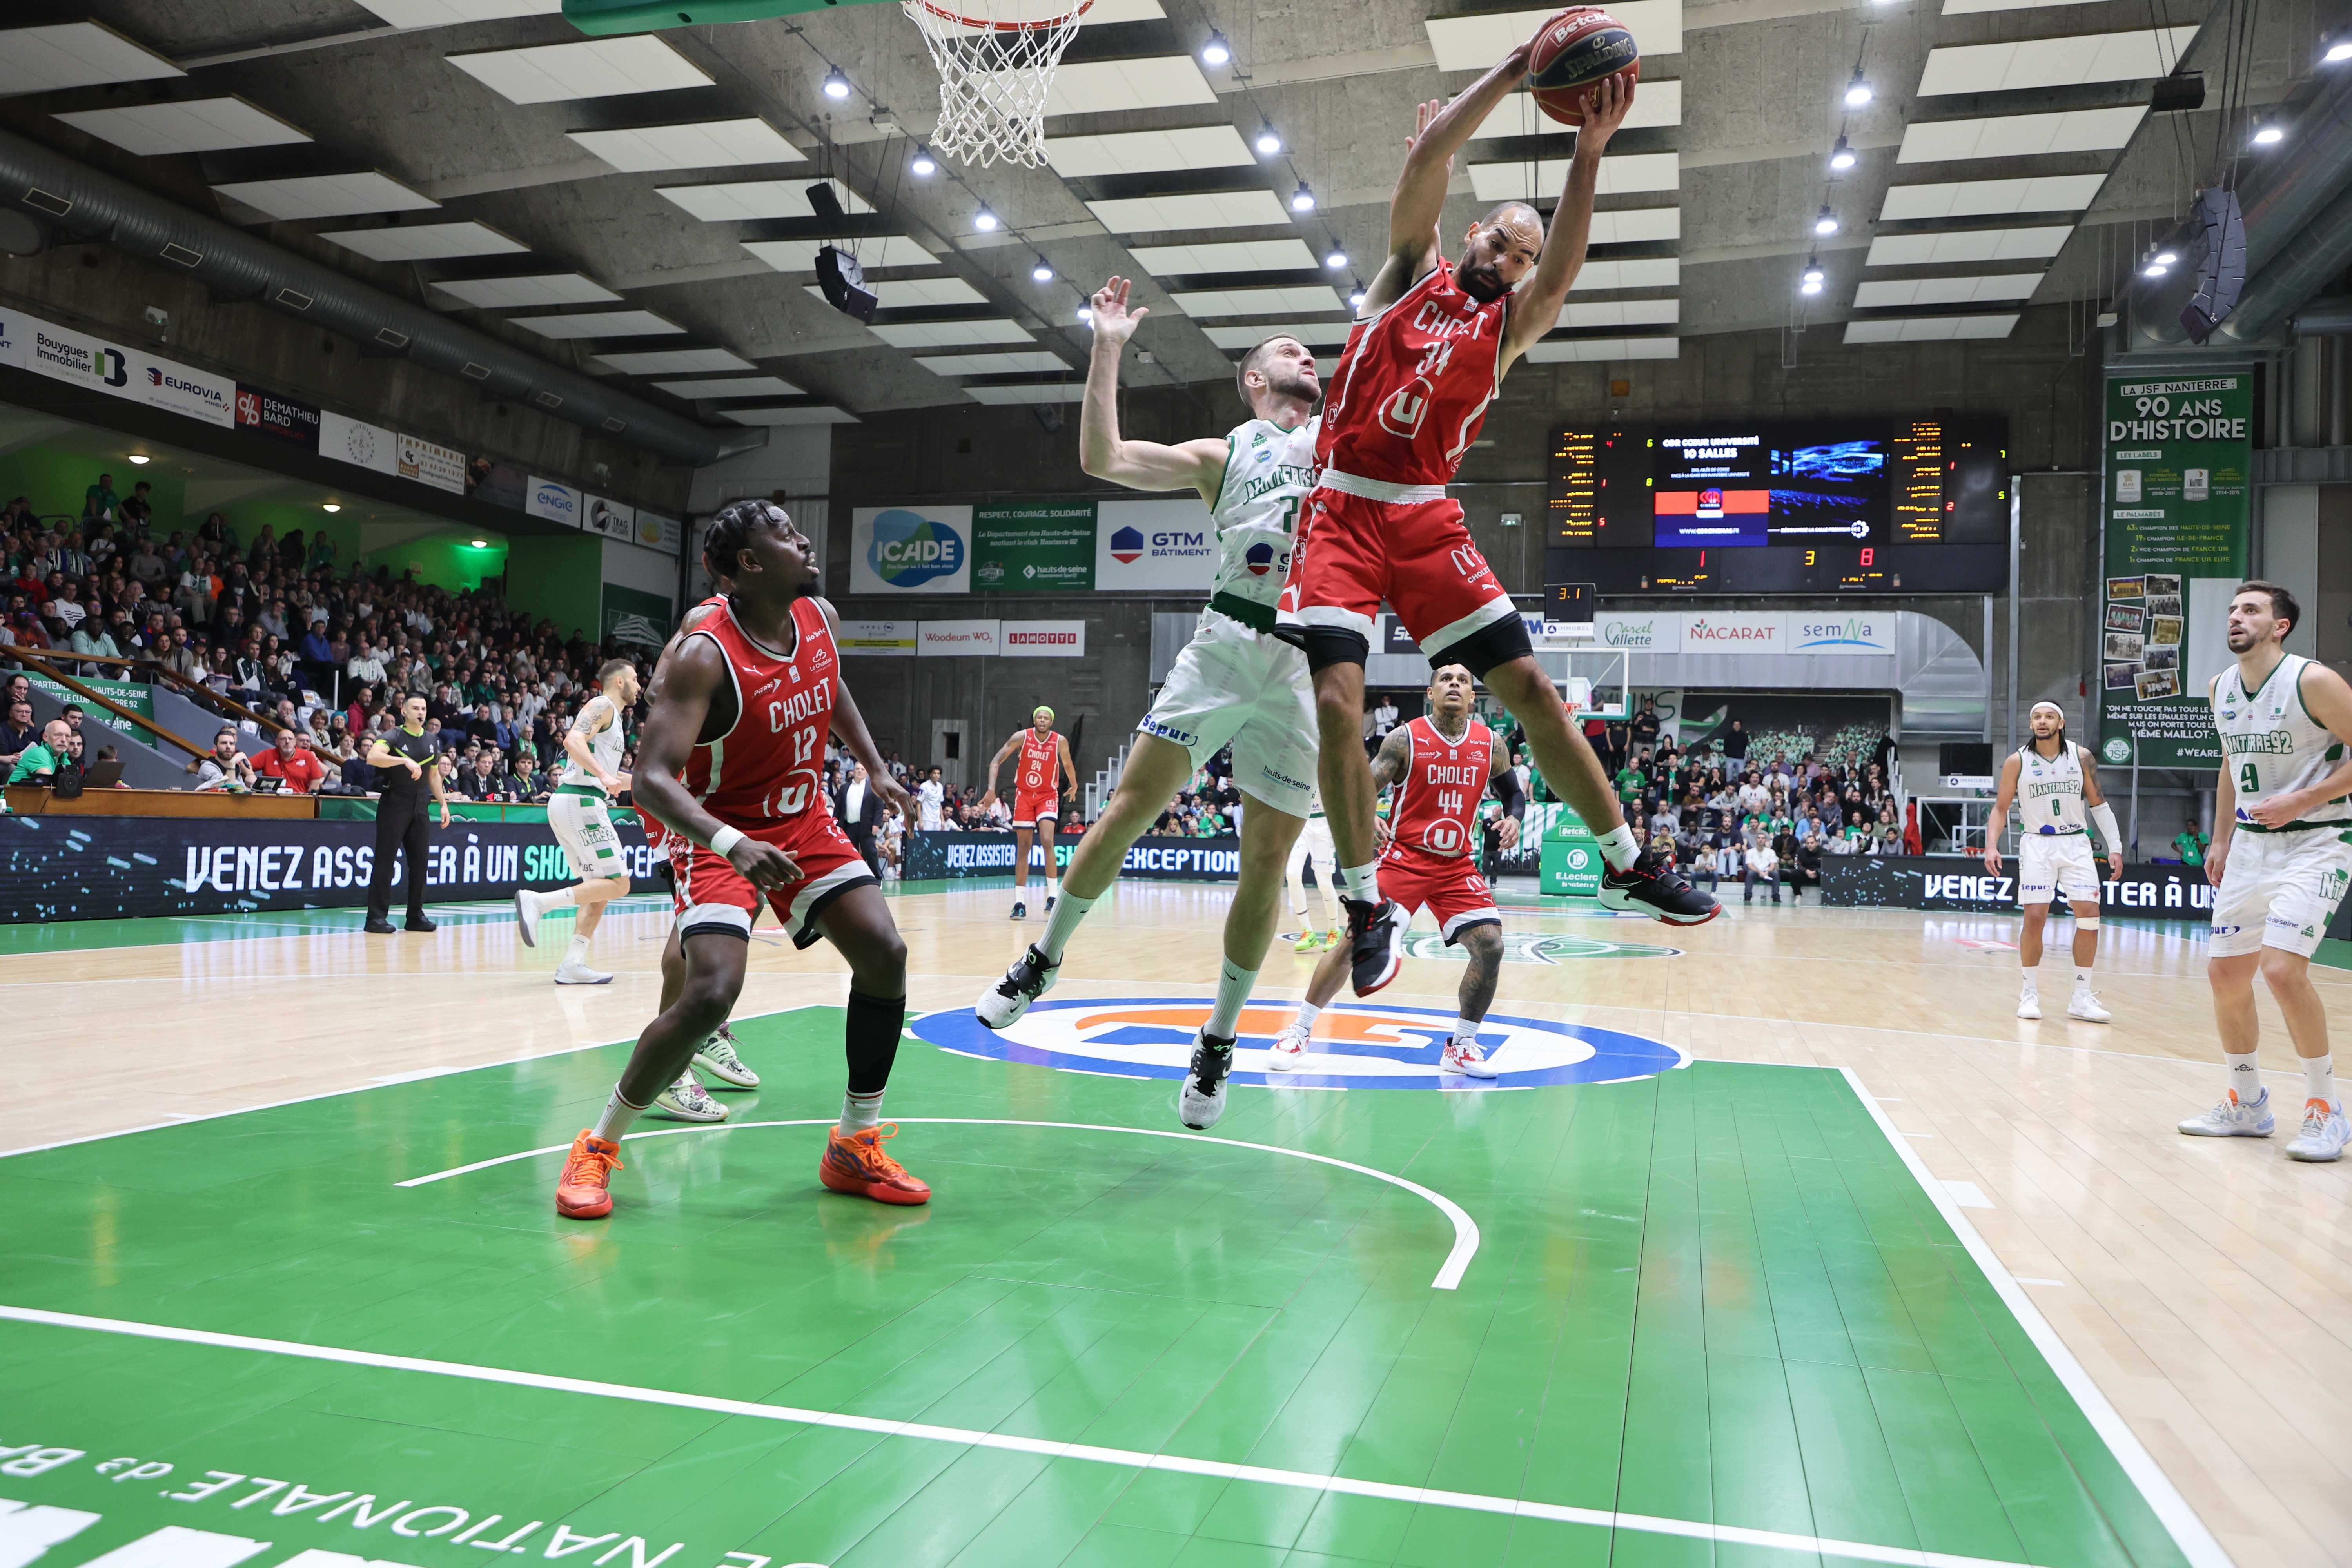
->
<box><xmin>555</xmin><ymin>501</ymin><xmax>931</xmax><ymax>1220</ymax></box>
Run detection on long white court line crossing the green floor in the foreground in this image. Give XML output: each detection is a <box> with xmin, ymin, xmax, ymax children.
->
<box><xmin>0</xmin><ymin>1298</ymin><xmax>2060</xmax><ymax>1568</ymax></box>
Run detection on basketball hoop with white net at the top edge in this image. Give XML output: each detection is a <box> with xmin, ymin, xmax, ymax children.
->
<box><xmin>903</xmin><ymin>0</ymin><xmax>1094</xmax><ymax>169</ymax></box>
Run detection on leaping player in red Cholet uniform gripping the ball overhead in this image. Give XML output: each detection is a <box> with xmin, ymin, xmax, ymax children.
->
<box><xmin>1277</xmin><ymin>55</ymin><xmax>1722</xmax><ymax>997</ymax></box>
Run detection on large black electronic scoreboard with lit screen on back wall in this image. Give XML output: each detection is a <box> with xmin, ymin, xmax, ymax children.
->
<box><xmin>1545</xmin><ymin>416</ymin><xmax>2009</xmax><ymax>595</ymax></box>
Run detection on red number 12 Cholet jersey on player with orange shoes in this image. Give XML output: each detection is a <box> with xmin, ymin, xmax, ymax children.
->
<box><xmin>682</xmin><ymin>599</ymin><xmax>842</xmax><ymax>828</ymax></box>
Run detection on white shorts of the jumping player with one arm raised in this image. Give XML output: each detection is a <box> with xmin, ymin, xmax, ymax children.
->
<box><xmin>1136</xmin><ymin>609</ymin><xmax>1317</xmax><ymax>818</ymax></box>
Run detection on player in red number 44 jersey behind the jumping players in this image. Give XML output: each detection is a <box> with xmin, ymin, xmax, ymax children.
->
<box><xmin>1265</xmin><ymin>665</ymin><xmax>1519</xmax><ymax>1079</ymax></box>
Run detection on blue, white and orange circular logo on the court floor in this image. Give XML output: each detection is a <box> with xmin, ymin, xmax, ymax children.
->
<box><xmin>913</xmin><ymin>997</ymin><xmax>1689</xmax><ymax>1089</ymax></box>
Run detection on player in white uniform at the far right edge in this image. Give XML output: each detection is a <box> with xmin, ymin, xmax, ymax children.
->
<box><xmin>2180</xmin><ymin>583</ymin><xmax>2352</xmax><ymax>1161</ymax></box>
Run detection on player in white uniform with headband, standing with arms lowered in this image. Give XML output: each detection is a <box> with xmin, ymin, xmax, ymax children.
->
<box><xmin>1985</xmin><ymin>703</ymin><xmax>2124</xmax><ymax>1023</ymax></box>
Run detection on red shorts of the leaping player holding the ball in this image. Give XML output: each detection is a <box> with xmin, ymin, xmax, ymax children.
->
<box><xmin>1277</xmin><ymin>475</ymin><xmax>1517</xmax><ymax>656</ymax></box>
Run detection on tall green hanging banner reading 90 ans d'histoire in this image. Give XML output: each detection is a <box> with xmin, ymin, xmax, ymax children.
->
<box><xmin>2098</xmin><ymin>372</ymin><xmax>2253</xmax><ymax>769</ymax></box>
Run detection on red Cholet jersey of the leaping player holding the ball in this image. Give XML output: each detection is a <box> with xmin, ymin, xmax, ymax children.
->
<box><xmin>1315</xmin><ymin>261</ymin><xmax>1510</xmax><ymax>484</ymax></box>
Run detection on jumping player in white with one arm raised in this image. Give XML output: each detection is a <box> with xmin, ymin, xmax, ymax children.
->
<box><xmin>974</xmin><ymin>278</ymin><xmax>1322</xmax><ymax>1131</ymax></box>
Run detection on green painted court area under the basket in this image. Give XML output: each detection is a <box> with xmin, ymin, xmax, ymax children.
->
<box><xmin>0</xmin><ymin>1009</ymin><xmax>2185</xmax><ymax>1568</ymax></box>
